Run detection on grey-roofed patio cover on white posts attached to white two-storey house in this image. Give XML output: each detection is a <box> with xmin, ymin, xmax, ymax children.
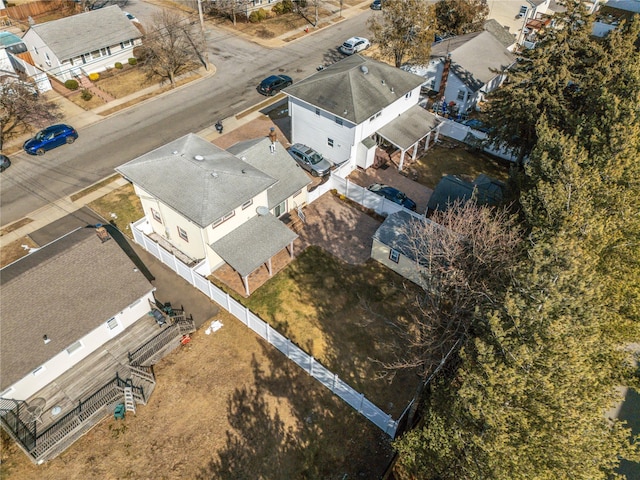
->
<box><xmin>376</xmin><ymin>105</ymin><xmax>440</xmax><ymax>170</ymax></box>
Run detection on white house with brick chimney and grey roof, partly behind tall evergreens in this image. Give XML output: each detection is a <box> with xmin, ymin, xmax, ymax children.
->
<box><xmin>403</xmin><ymin>31</ymin><xmax>516</xmax><ymax>114</ymax></box>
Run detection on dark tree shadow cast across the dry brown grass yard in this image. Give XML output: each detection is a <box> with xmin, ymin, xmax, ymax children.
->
<box><xmin>197</xmin><ymin>342</ymin><xmax>391</xmax><ymax>480</ymax></box>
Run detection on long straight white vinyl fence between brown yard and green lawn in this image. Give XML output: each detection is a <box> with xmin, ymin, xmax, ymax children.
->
<box><xmin>131</xmin><ymin>219</ymin><xmax>398</xmax><ymax>438</ymax></box>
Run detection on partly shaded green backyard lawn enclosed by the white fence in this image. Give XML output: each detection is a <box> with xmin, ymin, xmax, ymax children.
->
<box><xmin>238</xmin><ymin>247</ymin><xmax>419</xmax><ymax>418</ymax></box>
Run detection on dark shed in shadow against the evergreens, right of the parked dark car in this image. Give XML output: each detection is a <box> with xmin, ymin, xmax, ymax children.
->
<box><xmin>427</xmin><ymin>174</ymin><xmax>504</xmax><ymax>212</ymax></box>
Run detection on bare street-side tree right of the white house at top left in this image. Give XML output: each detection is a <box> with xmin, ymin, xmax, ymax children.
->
<box><xmin>140</xmin><ymin>10</ymin><xmax>206</xmax><ymax>87</ymax></box>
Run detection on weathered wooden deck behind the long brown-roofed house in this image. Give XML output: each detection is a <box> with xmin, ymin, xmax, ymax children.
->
<box><xmin>27</xmin><ymin>315</ymin><xmax>161</xmax><ymax>431</ymax></box>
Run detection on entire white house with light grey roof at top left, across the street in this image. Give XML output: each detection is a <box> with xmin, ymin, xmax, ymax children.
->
<box><xmin>22</xmin><ymin>5</ymin><xmax>142</xmax><ymax>82</ymax></box>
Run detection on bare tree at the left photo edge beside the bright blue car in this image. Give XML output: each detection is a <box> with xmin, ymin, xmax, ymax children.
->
<box><xmin>0</xmin><ymin>77</ymin><xmax>60</xmax><ymax>149</ymax></box>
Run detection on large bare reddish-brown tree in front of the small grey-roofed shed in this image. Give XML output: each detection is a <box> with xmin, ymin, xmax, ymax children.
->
<box><xmin>385</xmin><ymin>201</ymin><xmax>522</xmax><ymax>424</ymax></box>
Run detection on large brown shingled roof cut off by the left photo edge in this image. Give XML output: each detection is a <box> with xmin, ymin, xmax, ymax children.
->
<box><xmin>0</xmin><ymin>228</ymin><xmax>153</xmax><ymax>391</ymax></box>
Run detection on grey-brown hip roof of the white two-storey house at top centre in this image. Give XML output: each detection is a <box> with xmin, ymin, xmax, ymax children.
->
<box><xmin>283</xmin><ymin>54</ymin><xmax>424</xmax><ymax>124</ymax></box>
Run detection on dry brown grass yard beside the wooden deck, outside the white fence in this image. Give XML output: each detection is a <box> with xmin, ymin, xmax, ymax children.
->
<box><xmin>0</xmin><ymin>312</ymin><xmax>390</xmax><ymax>480</ymax></box>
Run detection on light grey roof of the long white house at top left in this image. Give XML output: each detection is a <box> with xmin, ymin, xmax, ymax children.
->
<box><xmin>30</xmin><ymin>5</ymin><xmax>142</xmax><ymax>60</ymax></box>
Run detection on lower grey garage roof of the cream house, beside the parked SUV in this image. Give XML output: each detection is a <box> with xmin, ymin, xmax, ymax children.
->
<box><xmin>227</xmin><ymin>138</ymin><xmax>311</xmax><ymax>210</ymax></box>
